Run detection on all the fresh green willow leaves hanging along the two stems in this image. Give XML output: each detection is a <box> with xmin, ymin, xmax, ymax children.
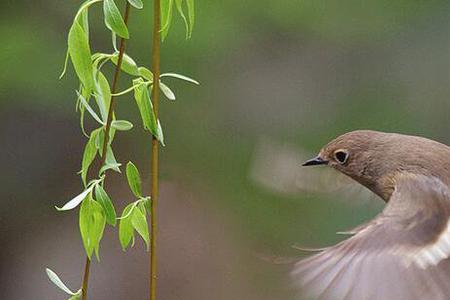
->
<box><xmin>46</xmin><ymin>0</ymin><xmax>199</xmax><ymax>300</ymax></box>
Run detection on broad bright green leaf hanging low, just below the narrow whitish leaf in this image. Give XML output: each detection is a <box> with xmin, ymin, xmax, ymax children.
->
<box><xmin>80</xmin><ymin>194</ymin><xmax>106</xmax><ymax>259</ymax></box>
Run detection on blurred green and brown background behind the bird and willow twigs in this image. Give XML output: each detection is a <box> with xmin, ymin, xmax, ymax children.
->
<box><xmin>0</xmin><ymin>0</ymin><xmax>450</xmax><ymax>300</ymax></box>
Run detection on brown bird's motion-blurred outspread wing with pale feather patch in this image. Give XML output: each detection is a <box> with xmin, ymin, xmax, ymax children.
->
<box><xmin>292</xmin><ymin>174</ymin><xmax>450</xmax><ymax>300</ymax></box>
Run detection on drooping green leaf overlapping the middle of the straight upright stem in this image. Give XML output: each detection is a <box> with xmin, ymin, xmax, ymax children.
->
<box><xmin>133</xmin><ymin>78</ymin><xmax>158</xmax><ymax>135</ymax></box>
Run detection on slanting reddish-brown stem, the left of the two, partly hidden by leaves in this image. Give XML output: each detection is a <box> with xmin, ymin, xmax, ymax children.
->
<box><xmin>81</xmin><ymin>1</ymin><xmax>130</xmax><ymax>300</ymax></box>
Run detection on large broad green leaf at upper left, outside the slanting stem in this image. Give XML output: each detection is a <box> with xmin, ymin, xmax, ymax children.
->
<box><xmin>68</xmin><ymin>21</ymin><xmax>94</xmax><ymax>91</ymax></box>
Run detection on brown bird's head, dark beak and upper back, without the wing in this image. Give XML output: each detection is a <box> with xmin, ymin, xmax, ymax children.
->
<box><xmin>303</xmin><ymin>130</ymin><xmax>450</xmax><ymax>201</ymax></box>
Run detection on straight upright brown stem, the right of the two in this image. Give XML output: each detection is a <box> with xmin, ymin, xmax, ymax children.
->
<box><xmin>150</xmin><ymin>0</ymin><xmax>161</xmax><ymax>300</ymax></box>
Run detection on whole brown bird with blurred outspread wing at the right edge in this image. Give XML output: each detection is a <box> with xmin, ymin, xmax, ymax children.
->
<box><xmin>292</xmin><ymin>130</ymin><xmax>450</xmax><ymax>300</ymax></box>
